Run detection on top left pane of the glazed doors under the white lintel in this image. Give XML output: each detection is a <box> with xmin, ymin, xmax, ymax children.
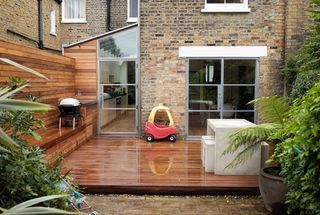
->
<box><xmin>189</xmin><ymin>60</ymin><xmax>221</xmax><ymax>84</ymax></box>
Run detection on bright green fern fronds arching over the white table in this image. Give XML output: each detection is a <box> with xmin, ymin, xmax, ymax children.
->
<box><xmin>222</xmin><ymin>96</ymin><xmax>289</xmax><ymax>168</ymax></box>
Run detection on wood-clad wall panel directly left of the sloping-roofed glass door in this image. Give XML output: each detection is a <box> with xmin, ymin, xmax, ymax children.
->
<box><xmin>64</xmin><ymin>40</ymin><xmax>98</xmax><ymax>99</ymax></box>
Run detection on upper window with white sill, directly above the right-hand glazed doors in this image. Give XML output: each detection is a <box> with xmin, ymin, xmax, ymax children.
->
<box><xmin>201</xmin><ymin>0</ymin><xmax>250</xmax><ymax>12</ymax></box>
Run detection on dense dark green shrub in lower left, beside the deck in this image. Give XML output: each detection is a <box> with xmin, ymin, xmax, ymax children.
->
<box><xmin>0</xmin><ymin>140</ymin><xmax>65</xmax><ymax>208</ymax></box>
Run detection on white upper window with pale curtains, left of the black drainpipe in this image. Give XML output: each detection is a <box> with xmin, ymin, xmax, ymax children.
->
<box><xmin>62</xmin><ymin>0</ymin><xmax>86</xmax><ymax>23</ymax></box>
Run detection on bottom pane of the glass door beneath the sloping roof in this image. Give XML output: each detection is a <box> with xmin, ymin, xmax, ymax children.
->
<box><xmin>101</xmin><ymin>110</ymin><xmax>136</xmax><ymax>132</ymax></box>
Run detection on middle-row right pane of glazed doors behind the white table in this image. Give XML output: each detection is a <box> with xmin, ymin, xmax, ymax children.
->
<box><xmin>223</xmin><ymin>86</ymin><xmax>254</xmax><ymax>110</ymax></box>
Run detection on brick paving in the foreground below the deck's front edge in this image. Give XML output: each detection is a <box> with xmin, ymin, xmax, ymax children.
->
<box><xmin>87</xmin><ymin>195</ymin><xmax>269</xmax><ymax>215</ymax></box>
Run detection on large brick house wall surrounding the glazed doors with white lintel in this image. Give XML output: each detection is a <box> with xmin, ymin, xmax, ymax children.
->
<box><xmin>140</xmin><ymin>0</ymin><xmax>308</xmax><ymax>136</ymax></box>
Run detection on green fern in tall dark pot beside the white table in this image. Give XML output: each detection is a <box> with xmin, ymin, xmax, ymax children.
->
<box><xmin>223</xmin><ymin>96</ymin><xmax>290</xmax><ymax>213</ymax></box>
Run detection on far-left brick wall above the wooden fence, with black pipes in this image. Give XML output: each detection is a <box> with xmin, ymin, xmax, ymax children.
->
<box><xmin>0</xmin><ymin>0</ymin><xmax>61</xmax><ymax>51</ymax></box>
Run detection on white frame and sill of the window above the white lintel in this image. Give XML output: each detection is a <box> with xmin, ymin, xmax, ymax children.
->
<box><xmin>201</xmin><ymin>0</ymin><xmax>251</xmax><ymax>13</ymax></box>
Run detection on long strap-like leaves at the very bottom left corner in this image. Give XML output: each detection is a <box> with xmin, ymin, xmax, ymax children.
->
<box><xmin>0</xmin><ymin>195</ymin><xmax>83</xmax><ymax>215</ymax></box>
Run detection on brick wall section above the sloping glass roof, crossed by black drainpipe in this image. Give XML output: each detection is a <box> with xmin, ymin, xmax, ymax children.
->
<box><xmin>61</xmin><ymin>0</ymin><xmax>128</xmax><ymax>44</ymax></box>
